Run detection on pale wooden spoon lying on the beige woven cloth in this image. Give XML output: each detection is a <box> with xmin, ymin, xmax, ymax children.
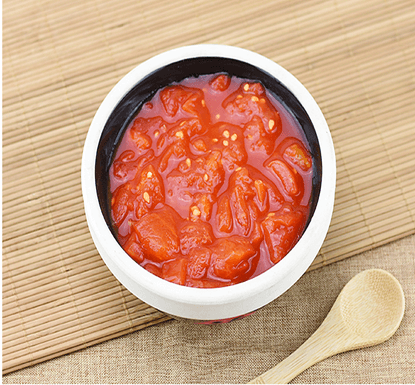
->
<box><xmin>250</xmin><ymin>269</ymin><xmax>405</xmax><ymax>384</ymax></box>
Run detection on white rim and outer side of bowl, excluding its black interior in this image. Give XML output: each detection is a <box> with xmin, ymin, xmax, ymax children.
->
<box><xmin>81</xmin><ymin>44</ymin><xmax>336</xmax><ymax>319</ymax></box>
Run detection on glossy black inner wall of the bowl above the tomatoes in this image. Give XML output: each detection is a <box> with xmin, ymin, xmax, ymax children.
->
<box><xmin>95</xmin><ymin>57</ymin><xmax>322</xmax><ymax>237</ymax></box>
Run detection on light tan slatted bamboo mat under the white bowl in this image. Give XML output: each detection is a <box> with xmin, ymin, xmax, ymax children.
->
<box><xmin>3</xmin><ymin>0</ymin><xmax>415</xmax><ymax>373</ymax></box>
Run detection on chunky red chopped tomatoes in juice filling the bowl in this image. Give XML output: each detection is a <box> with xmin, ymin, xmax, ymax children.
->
<box><xmin>110</xmin><ymin>74</ymin><xmax>313</xmax><ymax>288</ymax></box>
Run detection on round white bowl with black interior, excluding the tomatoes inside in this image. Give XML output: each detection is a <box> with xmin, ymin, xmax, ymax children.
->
<box><xmin>82</xmin><ymin>45</ymin><xmax>336</xmax><ymax>320</ymax></box>
